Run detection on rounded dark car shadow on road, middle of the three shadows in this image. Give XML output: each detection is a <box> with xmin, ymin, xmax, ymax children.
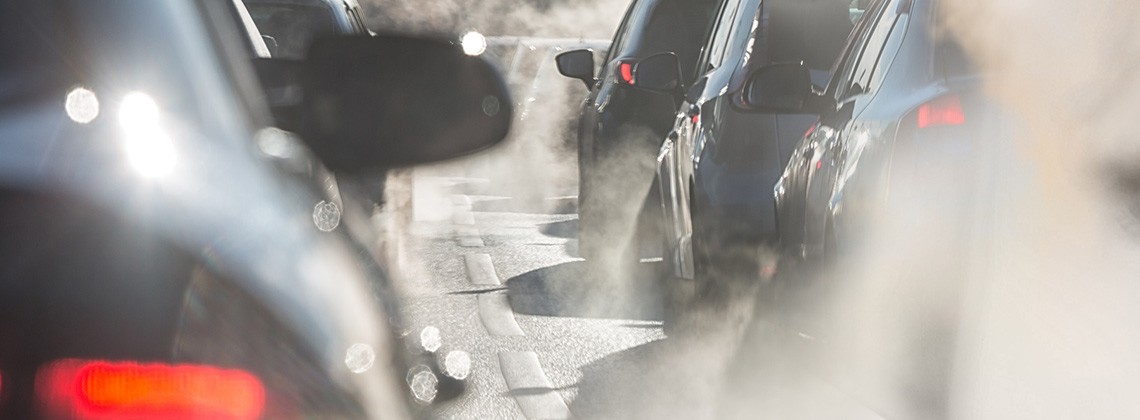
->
<box><xmin>506</xmin><ymin>261</ymin><xmax>663</xmax><ymax>321</ymax></box>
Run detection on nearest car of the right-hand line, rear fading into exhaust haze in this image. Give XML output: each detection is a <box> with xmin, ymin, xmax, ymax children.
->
<box><xmin>744</xmin><ymin>0</ymin><xmax>989</xmax><ymax>333</ymax></box>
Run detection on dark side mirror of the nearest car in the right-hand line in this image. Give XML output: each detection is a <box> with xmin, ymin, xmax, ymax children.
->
<box><xmin>741</xmin><ymin>63</ymin><xmax>819</xmax><ymax>114</ymax></box>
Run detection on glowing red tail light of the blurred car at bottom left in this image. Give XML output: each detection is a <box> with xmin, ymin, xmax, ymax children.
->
<box><xmin>35</xmin><ymin>360</ymin><xmax>266</xmax><ymax>419</ymax></box>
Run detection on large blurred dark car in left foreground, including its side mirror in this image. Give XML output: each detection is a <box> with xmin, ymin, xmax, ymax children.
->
<box><xmin>0</xmin><ymin>0</ymin><xmax>511</xmax><ymax>419</ymax></box>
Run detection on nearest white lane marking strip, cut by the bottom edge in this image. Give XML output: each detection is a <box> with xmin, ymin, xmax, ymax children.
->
<box><xmin>499</xmin><ymin>352</ymin><xmax>570</xmax><ymax>419</ymax></box>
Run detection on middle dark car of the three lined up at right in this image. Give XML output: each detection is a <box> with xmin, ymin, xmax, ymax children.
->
<box><xmin>644</xmin><ymin>0</ymin><xmax>853</xmax><ymax>283</ymax></box>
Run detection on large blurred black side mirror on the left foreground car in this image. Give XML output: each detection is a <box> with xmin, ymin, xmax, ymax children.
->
<box><xmin>294</xmin><ymin>35</ymin><xmax>512</xmax><ymax>172</ymax></box>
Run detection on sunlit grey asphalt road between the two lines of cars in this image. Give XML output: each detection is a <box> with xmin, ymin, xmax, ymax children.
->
<box><xmin>389</xmin><ymin>156</ymin><xmax>879</xmax><ymax>419</ymax></box>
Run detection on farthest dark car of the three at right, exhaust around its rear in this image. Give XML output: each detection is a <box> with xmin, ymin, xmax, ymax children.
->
<box><xmin>556</xmin><ymin>0</ymin><xmax>719</xmax><ymax>269</ymax></box>
